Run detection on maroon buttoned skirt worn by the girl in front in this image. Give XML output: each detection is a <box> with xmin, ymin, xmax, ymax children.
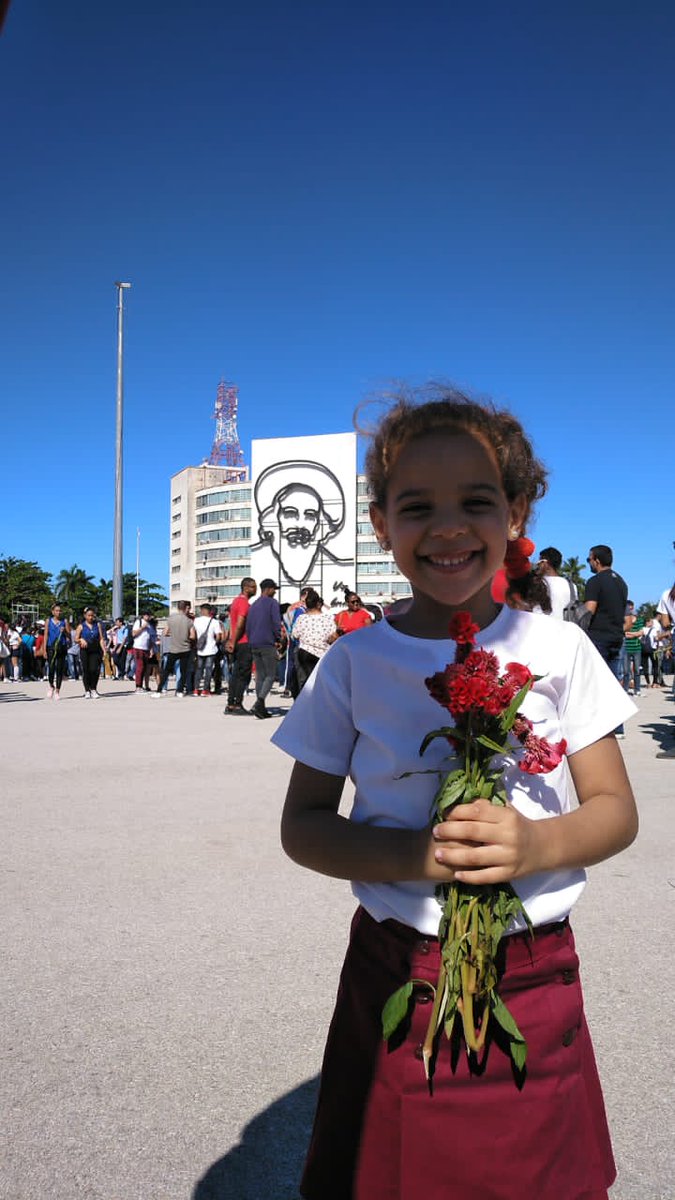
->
<box><xmin>300</xmin><ymin>908</ymin><xmax>616</xmax><ymax>1200</ymax></box>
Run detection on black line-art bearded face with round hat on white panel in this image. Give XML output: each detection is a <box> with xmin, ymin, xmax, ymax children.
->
<box><xmin>251</xmin><ymin>461</ymin><xmax>350</xmax><ymax>584</ymax></box>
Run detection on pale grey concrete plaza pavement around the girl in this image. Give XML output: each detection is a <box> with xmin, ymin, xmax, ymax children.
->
<box><xmin>0</xmin><ymin>683</ymin><xmax>675</xmax><ymax>1200</ymax></box>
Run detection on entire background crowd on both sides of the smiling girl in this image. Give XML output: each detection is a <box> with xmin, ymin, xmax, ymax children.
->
<box><xmin>0</xmin><ymin>564</ymin><xmax>675</xmax><ymax>710</ymax></box>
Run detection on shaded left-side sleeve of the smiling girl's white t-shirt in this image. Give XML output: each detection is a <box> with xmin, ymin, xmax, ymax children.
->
<box><xmin>271</xmin><ymin>643</ymin><xmax>357</xmax><ymax>775</ymax></box>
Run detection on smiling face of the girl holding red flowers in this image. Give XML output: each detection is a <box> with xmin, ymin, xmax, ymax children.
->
<box><xmin>370</xmin><ymin>431</ymin><xmax>526</xmax><ymax>637</ymax></box>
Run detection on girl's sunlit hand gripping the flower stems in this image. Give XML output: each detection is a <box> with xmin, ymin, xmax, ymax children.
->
<box><xmin>432</xmin><ymin>800</ymin><xmax>542</xmax><ymax>883</ymax></box>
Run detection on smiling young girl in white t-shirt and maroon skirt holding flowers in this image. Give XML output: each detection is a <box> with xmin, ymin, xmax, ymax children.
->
<box><xmin>273</xmin><ymin>392</ymin><xmax>638</xmax><ymax>1200</ymax></box>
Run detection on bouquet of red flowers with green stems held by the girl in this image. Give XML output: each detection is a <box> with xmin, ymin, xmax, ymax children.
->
<box><xmin>382</xmin><ymin>612</ymin><xmax>566</xmax><ymax>1079</ymax></box>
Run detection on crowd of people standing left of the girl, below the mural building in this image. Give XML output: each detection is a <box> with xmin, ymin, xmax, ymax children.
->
<box><xmin>0</xmin><ymin>577</ymin><xmax>374</xmax><ymax>718</ymax></box>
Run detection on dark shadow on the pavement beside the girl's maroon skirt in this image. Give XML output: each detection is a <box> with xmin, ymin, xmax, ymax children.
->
<box><xmin>192</xmin><ymin>1075</ymin><xmax>318</xmax><ymax>1200</ymax></box>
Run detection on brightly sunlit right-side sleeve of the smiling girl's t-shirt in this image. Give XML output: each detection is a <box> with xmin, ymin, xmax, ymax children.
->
<box><xmin>560</xmin><ymin>626</ymin><xmax>637</xmax><ymax>755</ymax></box>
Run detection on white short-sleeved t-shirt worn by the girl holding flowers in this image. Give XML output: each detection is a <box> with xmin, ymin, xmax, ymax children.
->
<box><xmin>271</xmin><ymin>606</ymin><xmax>637</xmax><ymax>935</ymax></box>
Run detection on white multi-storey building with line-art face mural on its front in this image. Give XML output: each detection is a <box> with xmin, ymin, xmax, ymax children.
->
<box><xmin>169</xmin><ymin>433</ymin><xmax>410</xmax><ymax>608</ymax></box>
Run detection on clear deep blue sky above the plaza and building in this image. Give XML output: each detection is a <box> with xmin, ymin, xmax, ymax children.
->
<box><xmin>0</xmin><ymin>0</ymin><xmax>675</xmax><ymax>602</ymax></box>
